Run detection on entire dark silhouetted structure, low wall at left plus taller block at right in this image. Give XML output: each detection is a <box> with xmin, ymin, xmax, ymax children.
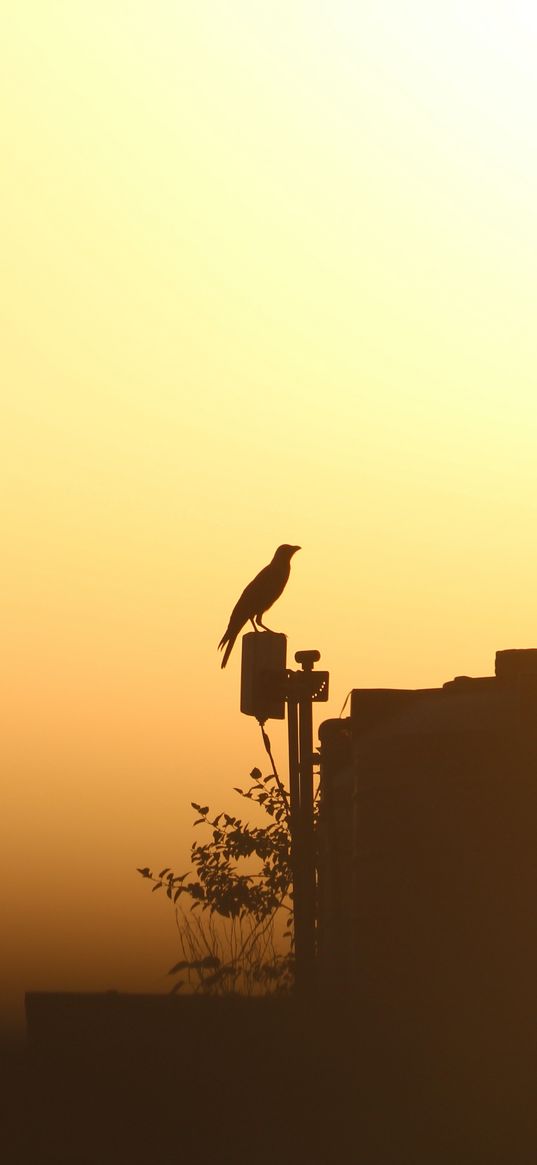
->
<box><xmin>11</xmin><ymin>651</ymin><xmax>537</xmax><ymax>1165</ymax></box>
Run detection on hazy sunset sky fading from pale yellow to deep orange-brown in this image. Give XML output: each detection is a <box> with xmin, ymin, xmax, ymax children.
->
<box><xmin>0</xmin><ymin>0</ymin><xmax>537</xmax><ymax>1018</ymax></box>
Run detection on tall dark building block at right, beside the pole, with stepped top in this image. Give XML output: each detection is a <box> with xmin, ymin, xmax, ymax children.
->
<box><xmin>319</xmin><ymin>650</ymin><xmax>537</xmax><ymax>1163</ymax></box>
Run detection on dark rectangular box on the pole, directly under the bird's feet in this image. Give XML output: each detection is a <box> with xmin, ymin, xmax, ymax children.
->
<box><xmin>240</xmin><ymin>631</ymin><xmax>287</xmax><ymax>723</ymax></box>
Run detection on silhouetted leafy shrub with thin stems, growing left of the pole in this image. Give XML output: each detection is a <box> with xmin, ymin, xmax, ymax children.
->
<box><xmin>139</xmin><ymin>764</ymin><xmax>294</xmax><ymax>990</ymax></box>
